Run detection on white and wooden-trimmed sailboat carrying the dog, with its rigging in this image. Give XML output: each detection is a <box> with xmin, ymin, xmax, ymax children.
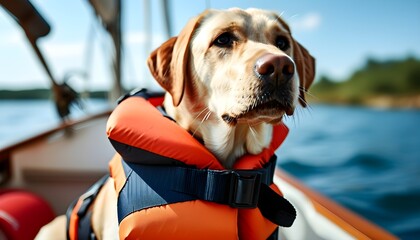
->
<box><xmin>0</xmin><ymin>0</ymin><xmax>398</xmax><ymax>240</ymax></box>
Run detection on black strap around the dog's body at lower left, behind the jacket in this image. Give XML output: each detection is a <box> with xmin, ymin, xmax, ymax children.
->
<box><xmin>66</xmin><ymin>175</ymin><xmax>109</xmax><ymax>240</ymax></box>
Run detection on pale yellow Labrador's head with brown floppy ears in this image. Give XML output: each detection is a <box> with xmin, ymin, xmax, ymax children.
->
<box><xmin>148</xmin><ymin>9</ymin><xmax>315</xmax><ymax>125</ymax></box>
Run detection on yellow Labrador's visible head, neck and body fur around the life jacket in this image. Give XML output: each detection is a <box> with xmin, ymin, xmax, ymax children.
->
<box><xmin>38</xmin><ymin>8</ymin><xmax>315</xmax><ymax>239</ymax></box>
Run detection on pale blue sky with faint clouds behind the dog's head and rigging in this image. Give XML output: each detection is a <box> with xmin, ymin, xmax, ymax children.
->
<box><xmin>0</xmin><ymin>0</ymin><xmax>420</xmax><ymax>90</ymax></box>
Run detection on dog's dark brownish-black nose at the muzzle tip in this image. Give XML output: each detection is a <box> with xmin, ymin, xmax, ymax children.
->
<box><xmin>254</xmin><ymin>53</ymin><xmax>295</xmax><ymax>83</ymax></box>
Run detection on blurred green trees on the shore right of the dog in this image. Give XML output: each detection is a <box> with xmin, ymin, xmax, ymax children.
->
<box><xmin>309</xmin><ymin>57</ymin><xmax>420</xmax><ymax>104</ymax></box>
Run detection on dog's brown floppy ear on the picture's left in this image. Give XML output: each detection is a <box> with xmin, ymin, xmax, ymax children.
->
<box><xmin>147</xmin><ymin>17</ymin><xmax>199</xmax><ymax>106</ymax></box>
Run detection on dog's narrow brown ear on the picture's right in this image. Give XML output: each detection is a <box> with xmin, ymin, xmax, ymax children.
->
<box><xmin>293</xmin><ymin>41</ymin><xmax>315</xmax><ymax>107</ymax></box>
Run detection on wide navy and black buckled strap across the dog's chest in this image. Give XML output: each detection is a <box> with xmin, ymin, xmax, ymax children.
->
<box><xmin>118</xmin><ymin>155</ymin><xmax>296</xmax><ymax>226</ymax></box>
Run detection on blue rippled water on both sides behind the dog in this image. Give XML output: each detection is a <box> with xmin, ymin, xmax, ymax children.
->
<box><xmin>0</xmin><ymin>101</ymin><xmax>420</xmax><ymax>239</ymax></box>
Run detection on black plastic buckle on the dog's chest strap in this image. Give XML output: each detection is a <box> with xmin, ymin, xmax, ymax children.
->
<box><xmin>229</xmin><ymin>170</ymin><xmax>261</xmax><ymax>208</ymax></box>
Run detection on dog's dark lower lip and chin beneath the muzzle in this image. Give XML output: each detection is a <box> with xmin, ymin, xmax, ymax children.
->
<box><xmin>222</xmin><ymin>101</ymin><xmax>294</xmax><ymax>125</ymax></box>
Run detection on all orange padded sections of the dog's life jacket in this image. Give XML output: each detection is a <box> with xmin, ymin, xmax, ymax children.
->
<box><xmin>107</xmin><ymin>92</ymin><xmax>288</xmax><ymax>240</ymax></box>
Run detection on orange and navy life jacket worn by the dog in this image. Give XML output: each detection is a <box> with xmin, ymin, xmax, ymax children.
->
<box><xmin>65</xmin><ymin>90</ymin><xmax>296</xmax><ymax>240</ymax></box>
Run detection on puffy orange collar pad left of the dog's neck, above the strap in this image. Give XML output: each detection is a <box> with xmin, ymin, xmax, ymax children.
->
<box><xmin>107</xmin><ymin>97</ymin><xmax>224</xmax><ymax>169</ymax></box>
